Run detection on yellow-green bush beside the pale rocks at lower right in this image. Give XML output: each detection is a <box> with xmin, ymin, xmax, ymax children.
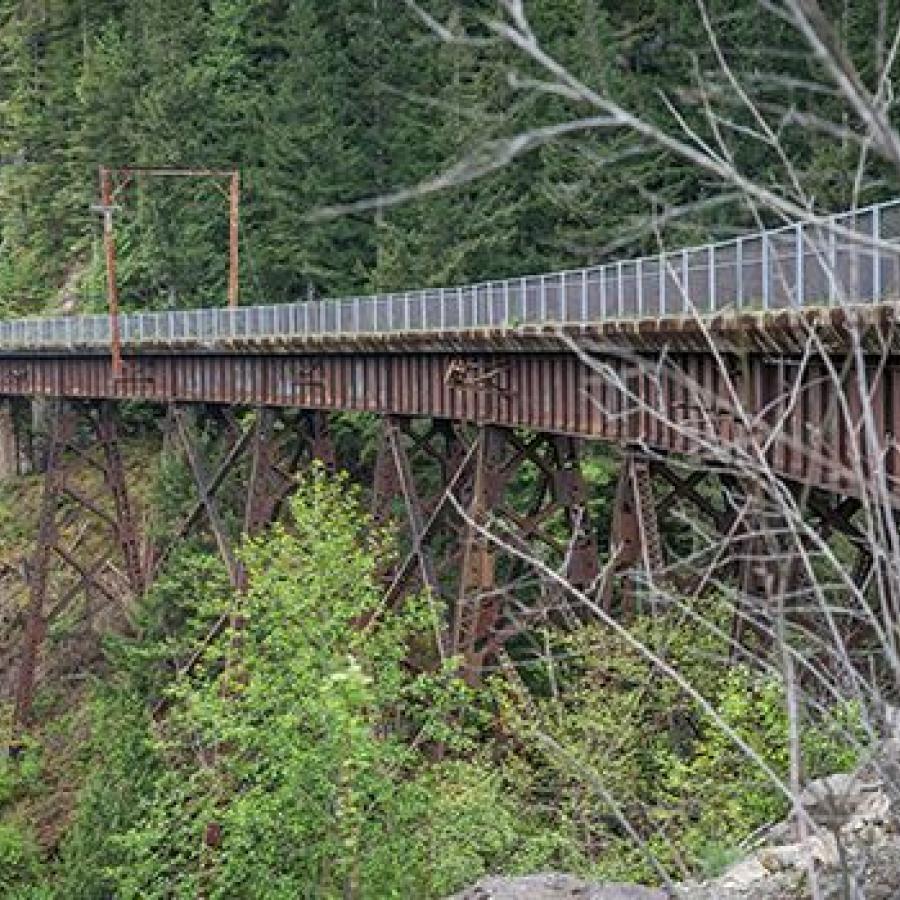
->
<box><xmin>503</xmin><ymin>604</ymin><xmax>863</xmax><ymax>881</ymax></box>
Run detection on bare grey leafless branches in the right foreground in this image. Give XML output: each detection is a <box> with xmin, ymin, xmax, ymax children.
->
<box><xmin>344</xmin><ymin>0</ymin><xmax>900</xmax><ymax>896</ymax></box>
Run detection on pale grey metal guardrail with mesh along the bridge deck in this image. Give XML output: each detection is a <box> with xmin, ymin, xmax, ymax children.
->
<box><xmin>0</xmin><ymin>200</ymin><xmax>900</xmax><ymax>349</ymax></box>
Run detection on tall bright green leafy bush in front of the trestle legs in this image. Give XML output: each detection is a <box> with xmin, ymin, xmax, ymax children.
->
<box><xmin>64</xmin><ymin>472</ymin><xmax>559</xmax><ymax>900</ymax></box>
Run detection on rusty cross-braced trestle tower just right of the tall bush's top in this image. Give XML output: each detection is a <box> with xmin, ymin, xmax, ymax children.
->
<box><xmin>373</xmin><ymin>417</ymin><xmax>599</xmax><ymax>682</ymax></box>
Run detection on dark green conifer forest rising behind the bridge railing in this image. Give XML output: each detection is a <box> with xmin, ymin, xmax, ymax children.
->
<box><xmin>0</xmin><ymin>0</ymin><xmax>891</xmax><ymax>312</ymax></box>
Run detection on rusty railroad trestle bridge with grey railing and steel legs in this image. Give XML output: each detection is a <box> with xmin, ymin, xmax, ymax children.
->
<box><xmin>0</xmin><ymin>203</ymin><xmax>900</xmax><ymax>723</ymax></box>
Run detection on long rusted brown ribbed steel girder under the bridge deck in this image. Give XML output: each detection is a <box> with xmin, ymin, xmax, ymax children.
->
<box><xmin>0</xmin><ymin>353</ymin><xmax>900</xmax><ymax>494</ymax></box>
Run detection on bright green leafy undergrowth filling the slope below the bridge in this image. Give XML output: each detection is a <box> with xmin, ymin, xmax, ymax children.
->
<box><xmin>0</xmin><ymin>471</ymin><xmax>857</xmax><ymax>900</ymax></box>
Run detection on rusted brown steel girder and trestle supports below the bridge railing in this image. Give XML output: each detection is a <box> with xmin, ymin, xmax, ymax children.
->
<box><xmin>0</xmin><ymin>307</ymin><xmax>900</xmax><ymax>706</ymax></box>
